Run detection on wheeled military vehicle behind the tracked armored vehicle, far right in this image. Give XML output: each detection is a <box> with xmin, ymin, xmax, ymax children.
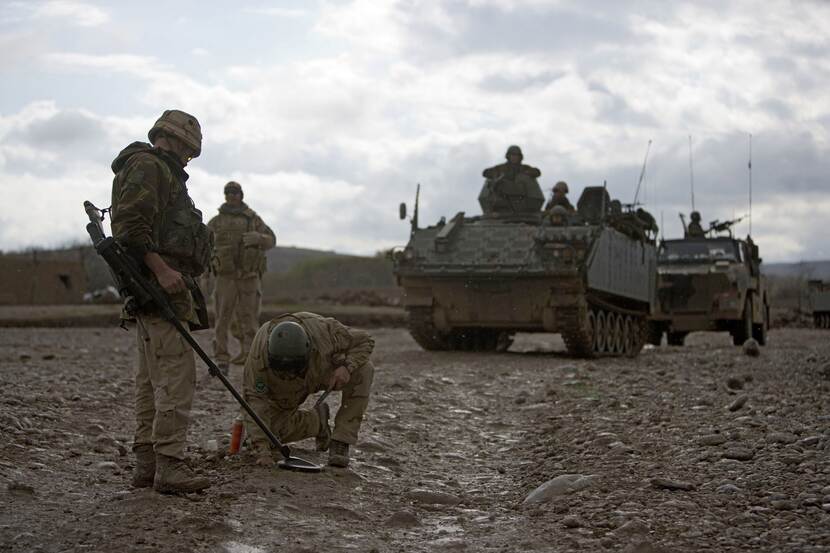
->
<box><xmin>648</xmin><ymin>221</ymin><xmax>769</xmax><ymax>346</ymax></box>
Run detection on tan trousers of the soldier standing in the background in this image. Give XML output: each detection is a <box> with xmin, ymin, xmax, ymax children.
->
<box><xmin>213</xmin><ymin>275</ymin><xmax>262</xmax><ymax>363</ymax></box>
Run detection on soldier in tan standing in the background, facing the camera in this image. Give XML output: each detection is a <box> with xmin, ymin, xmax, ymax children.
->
<box><xmin>208</xmin><ymin>181</ymin><xmax>277</xmax><ymax>375</ymax></box>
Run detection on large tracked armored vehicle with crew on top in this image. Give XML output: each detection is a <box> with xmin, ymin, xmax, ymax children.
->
<box><xmin>392</xmin><ymin>175</ymin><xmax>656</xmax><ymax>357</ymax></box>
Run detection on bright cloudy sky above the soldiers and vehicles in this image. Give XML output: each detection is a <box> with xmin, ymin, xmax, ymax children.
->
<box><xmin>0</xmin><ymin>0</ymin><xmax>830</xmax><ymax>261</ymax></box>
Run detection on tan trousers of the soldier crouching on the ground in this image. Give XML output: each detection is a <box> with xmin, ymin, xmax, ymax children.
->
<box><xmin>264</xmin><ymin>362</ymin><xmax>375</xmax><ymax>445</ymax></box>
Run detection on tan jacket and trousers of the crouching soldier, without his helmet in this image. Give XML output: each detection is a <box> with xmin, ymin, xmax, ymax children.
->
<box><xmin>243</xmin><ymin>312</ymin><xmax>375</xmax><ymax>455</ymax></box>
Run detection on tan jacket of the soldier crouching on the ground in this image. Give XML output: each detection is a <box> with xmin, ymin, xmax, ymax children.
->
<box><xmin>242</xmin><ymin>312</ymin><xmax>375</xmax><ymax>453</ymax></box>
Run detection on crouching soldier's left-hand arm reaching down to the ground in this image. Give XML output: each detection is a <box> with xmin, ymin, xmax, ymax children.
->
<box><xmin>242</xmin><ymin>324</ymin><xmax>277</xmax><ymax>455</ymax></box>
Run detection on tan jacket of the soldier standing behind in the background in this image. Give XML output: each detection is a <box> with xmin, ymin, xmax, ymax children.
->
<box><xmin>208</xmin><ymin>202</ymin><xmax>277</xmax><ymax>278</ymax></box>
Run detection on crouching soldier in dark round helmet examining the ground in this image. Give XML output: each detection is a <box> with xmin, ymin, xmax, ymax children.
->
<box><xmin>243</xmin><ymin>312</ymin><xmax>375</xmax><ymax>467</ymax></box>
